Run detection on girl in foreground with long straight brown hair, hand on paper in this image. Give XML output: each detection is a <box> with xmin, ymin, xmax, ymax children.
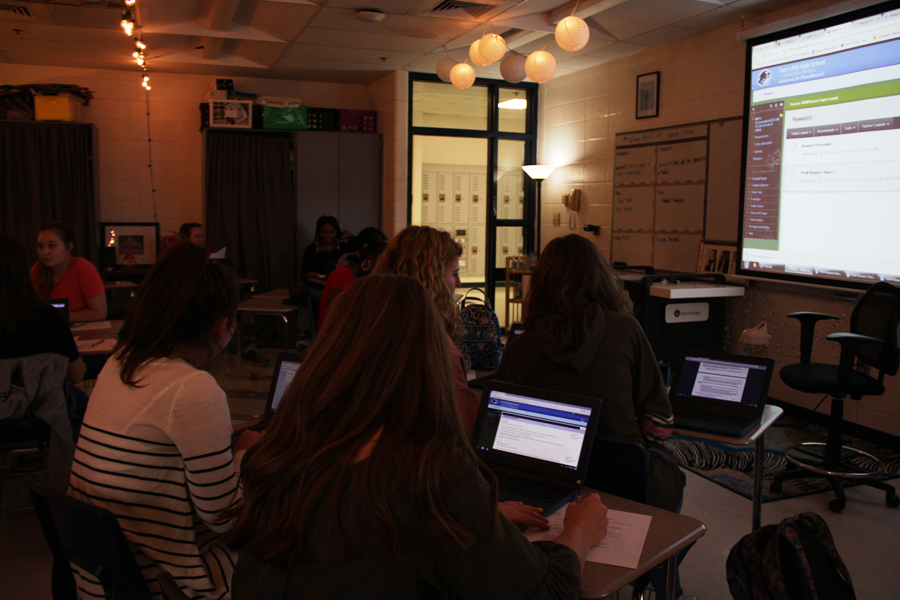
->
<box><xmin>226</xmin><ymin>275</ymin><xmax>607</xmax><ymax>600</ymax></box>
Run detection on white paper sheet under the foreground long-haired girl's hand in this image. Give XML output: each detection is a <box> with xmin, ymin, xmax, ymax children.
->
<box><xmin>525</xmin><ymin>506</ymin><xmax>651</xmax><ymax>569</ymax></box>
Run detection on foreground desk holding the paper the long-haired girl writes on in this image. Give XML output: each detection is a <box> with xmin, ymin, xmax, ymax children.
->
<box><xmin>581</xmin><ymin>493</ymin><xmax>706</xmax><ymax>600</ymax></box>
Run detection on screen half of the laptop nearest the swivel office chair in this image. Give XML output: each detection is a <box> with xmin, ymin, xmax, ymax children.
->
<box><xmin>672</xmin><ymin>351</ymin><xmax>769</xmax><ymax>406</ymax></box>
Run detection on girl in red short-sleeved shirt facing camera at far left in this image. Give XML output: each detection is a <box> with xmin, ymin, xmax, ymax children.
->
<box><xmin>31</xmin><ymin>221</ymin><xmax>106</xmax><ymax>323</ymax></box>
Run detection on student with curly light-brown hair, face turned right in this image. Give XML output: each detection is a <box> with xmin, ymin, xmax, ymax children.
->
<box><xmin>375</xmin><ymin>225</ymin><xmax>479</xmax><ymax>434</ymax></box>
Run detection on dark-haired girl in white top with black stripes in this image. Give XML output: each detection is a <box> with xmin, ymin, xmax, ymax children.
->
<box><xmin>69</xmin><ymin>244</ymin><xmax>260</xmax><ymax>598</ymax></box>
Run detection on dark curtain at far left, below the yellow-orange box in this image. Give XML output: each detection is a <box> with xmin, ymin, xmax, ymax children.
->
<box><xmin>0</xmin><ymin>121</ymin><xmax>100</xmax><ymax>262</ymax></box>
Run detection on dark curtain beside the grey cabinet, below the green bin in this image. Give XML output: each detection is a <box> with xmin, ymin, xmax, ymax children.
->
<box><xmin>206</xmin><ymin>130</ymin><xmax>297</xmax><ymax>290</ymax></box>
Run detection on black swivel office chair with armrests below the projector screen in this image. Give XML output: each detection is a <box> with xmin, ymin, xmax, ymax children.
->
<box><xmin>770</xmin><ymin>282</ymin><xmax>900</xmax><ymax>512</ymax></box>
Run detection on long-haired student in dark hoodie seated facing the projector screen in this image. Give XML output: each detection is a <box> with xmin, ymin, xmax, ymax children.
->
<box><xmin>497</xmin><ymin>234</ymin><xmax>685</xmax><ymax>511</ymax></box>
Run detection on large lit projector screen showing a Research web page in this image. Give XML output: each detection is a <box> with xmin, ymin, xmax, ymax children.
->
<box><xmin>737</xmin><ymin>1</ymin><xmax>900</xmax><ymax>288</ymax></box>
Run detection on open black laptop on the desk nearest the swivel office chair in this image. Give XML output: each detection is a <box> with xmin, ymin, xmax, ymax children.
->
<box><xmin>669</xmin><ymin>350</ymin><xmax>775</xmax><ymax>437</ymax></box>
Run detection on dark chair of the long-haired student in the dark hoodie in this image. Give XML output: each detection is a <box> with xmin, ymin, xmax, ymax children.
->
<box><xmin>584</xmin><ymin>434</ymin><xmax>651</xmax><ymax>600</ymax></box>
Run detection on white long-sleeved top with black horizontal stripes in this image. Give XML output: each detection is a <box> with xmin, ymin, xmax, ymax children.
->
<box><xmin>69</xmin><ymin>358</ymin><xmax>241</xmax><ymax>598</ymax></box>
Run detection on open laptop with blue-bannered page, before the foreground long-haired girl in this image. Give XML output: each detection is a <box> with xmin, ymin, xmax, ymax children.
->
<box><xmin>472</xmin><ymin>381</ymin><xmax>601</xmax><ymax>516</ymax></box>
